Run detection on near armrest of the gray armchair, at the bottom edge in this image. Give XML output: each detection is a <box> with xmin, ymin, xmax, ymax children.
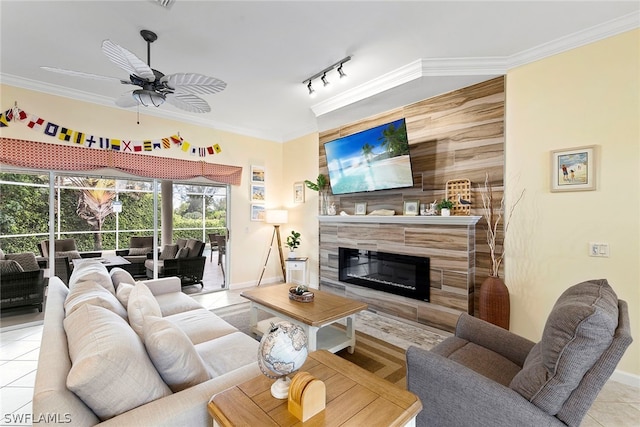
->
<box><xmin>407</xmin><ymin>346</ymin><xmax>566</xmax><ymax>427</ymax></box>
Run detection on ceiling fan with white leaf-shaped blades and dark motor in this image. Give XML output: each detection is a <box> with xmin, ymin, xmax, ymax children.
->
<box><xmin>40</xmin><ymin>30</ymin><xmax>227</xmax><ymax>113</ymax></box>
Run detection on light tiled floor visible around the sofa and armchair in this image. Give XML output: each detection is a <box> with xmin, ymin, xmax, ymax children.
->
<box><xmin>0</xmin><ymin>291</ymin><xmax>640</xmax><ymax>427</ymax></box>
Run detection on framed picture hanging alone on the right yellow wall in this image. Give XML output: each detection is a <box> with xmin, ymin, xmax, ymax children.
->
<box><xmin>551</xmin><ymin>145</ymin><xmax>596</xmax><ymax>192</ymax></box>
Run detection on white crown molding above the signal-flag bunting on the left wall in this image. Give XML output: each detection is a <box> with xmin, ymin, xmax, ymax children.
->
<box><xmin>0</xmin><ymin>73</ymin><xmax>283</xmax><ymax>142</ymax></box>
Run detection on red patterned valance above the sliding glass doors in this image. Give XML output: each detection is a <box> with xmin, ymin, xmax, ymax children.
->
<box><xmin>0</xmin><ymin>138</ymin><xmax>242</xmax><ymax>185</ymax></box>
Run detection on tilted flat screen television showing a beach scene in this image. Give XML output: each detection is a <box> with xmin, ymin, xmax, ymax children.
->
<box><xmin>324</xmin><ymin>119</ymin><xmax>413</xmax><ymax>194</ymax></box>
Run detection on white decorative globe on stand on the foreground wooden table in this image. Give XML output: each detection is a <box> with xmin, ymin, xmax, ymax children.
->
<box><xmin>258</xmin><ymin>321</ymin><xmax>308</xmax><ymax>399</ymax></box>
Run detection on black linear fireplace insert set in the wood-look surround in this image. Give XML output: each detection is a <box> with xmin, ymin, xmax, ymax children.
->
<box><xmin>338</xmin><ymin>247</ymin><xmax>430</xmax><ymax>301</ymax></box>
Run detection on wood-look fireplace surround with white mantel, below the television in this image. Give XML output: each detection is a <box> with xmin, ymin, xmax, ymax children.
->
<box><xmin>318</xmin><ymin>215</ymin><xmax>481</xmax><ymax>331</ymax></box>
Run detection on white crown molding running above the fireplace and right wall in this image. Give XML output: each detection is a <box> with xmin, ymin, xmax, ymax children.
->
<box><xmin>311</xmin><ymin>12</ymin><xmax>640</xmax><ymax>117</ymax></box>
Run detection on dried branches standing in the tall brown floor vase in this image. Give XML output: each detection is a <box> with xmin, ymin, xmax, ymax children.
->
<box><xmin>482</xmin><ymin>174</ymin><xmax>525</xmax><ymax>277</ymax></box>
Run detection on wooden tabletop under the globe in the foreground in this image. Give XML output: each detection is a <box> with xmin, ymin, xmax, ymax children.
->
<box><xmin>208</xmin><ymin>350</ymin><xmax>422</xmax><ymax>427</ymax></box>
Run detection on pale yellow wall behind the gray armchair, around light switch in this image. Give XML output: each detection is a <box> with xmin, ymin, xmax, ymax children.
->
<box><xmin>505</xmin><ymin>30</ymin><xmax>640</xmax><ymax>381</ymax></box>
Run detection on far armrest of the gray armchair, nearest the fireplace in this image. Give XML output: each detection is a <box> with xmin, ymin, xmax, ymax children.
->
<box><xmin>455</xmin><ymin>313</ymin><xmax>535</xmax><ymax>366</ymax></box>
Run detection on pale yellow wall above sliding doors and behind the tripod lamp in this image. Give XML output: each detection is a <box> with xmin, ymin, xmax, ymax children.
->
<box><xmin>0</xmin><ymin>85</ymin><xmax>283</xmax><ymax>286</ymax></box>
